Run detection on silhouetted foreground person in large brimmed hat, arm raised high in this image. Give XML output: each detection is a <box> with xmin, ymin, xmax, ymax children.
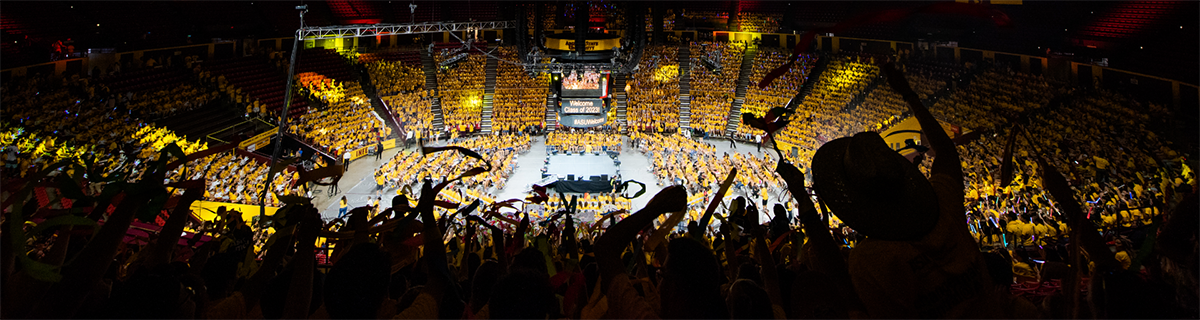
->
<box><xmin>812</xmin><ymin>64</ymin><xmax>1006</xmax><ymax>319</ymax></box>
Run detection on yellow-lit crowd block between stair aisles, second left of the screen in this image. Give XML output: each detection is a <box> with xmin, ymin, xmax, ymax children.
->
<box><xmin>436</xmin><ymin>54</ymin><xmax>487</xmax><ymax>132</ymax></box>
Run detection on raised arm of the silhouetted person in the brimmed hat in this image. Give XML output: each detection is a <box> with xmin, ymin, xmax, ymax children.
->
<box><xmin>883</xmin><ymin>62</ymin><xmax>962</xmax><ymax>183</ymax></box>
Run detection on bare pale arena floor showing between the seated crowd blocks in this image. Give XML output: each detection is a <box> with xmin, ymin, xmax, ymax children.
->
<box><xmin>313</xmin><ymin>137</ymin><xmax>768</xmax><ymax>219</ymax></box>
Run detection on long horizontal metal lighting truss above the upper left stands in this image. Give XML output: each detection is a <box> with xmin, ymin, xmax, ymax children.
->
<box><xmin>298</xmin><ymin>20</ymin><xmax>517</xmax><ymax>40</ymax></box>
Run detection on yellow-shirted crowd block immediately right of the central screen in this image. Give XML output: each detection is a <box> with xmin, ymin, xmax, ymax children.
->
<box><xmin>625</xmin><ymin>46</ymin><xmax>679</xmax><ymax>132</ymax></box>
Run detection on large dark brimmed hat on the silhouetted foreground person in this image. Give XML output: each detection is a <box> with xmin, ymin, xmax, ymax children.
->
<box><xmin>812</xmin><ymin>132</ymin><xmax>938</xmax><ymax>240</ymax></box>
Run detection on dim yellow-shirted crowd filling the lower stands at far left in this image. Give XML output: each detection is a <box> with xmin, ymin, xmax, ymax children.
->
<box><xmin>0</xmin><ymin>69</ymin><xmax>309</xmax><ymax>206</ymax></box>
